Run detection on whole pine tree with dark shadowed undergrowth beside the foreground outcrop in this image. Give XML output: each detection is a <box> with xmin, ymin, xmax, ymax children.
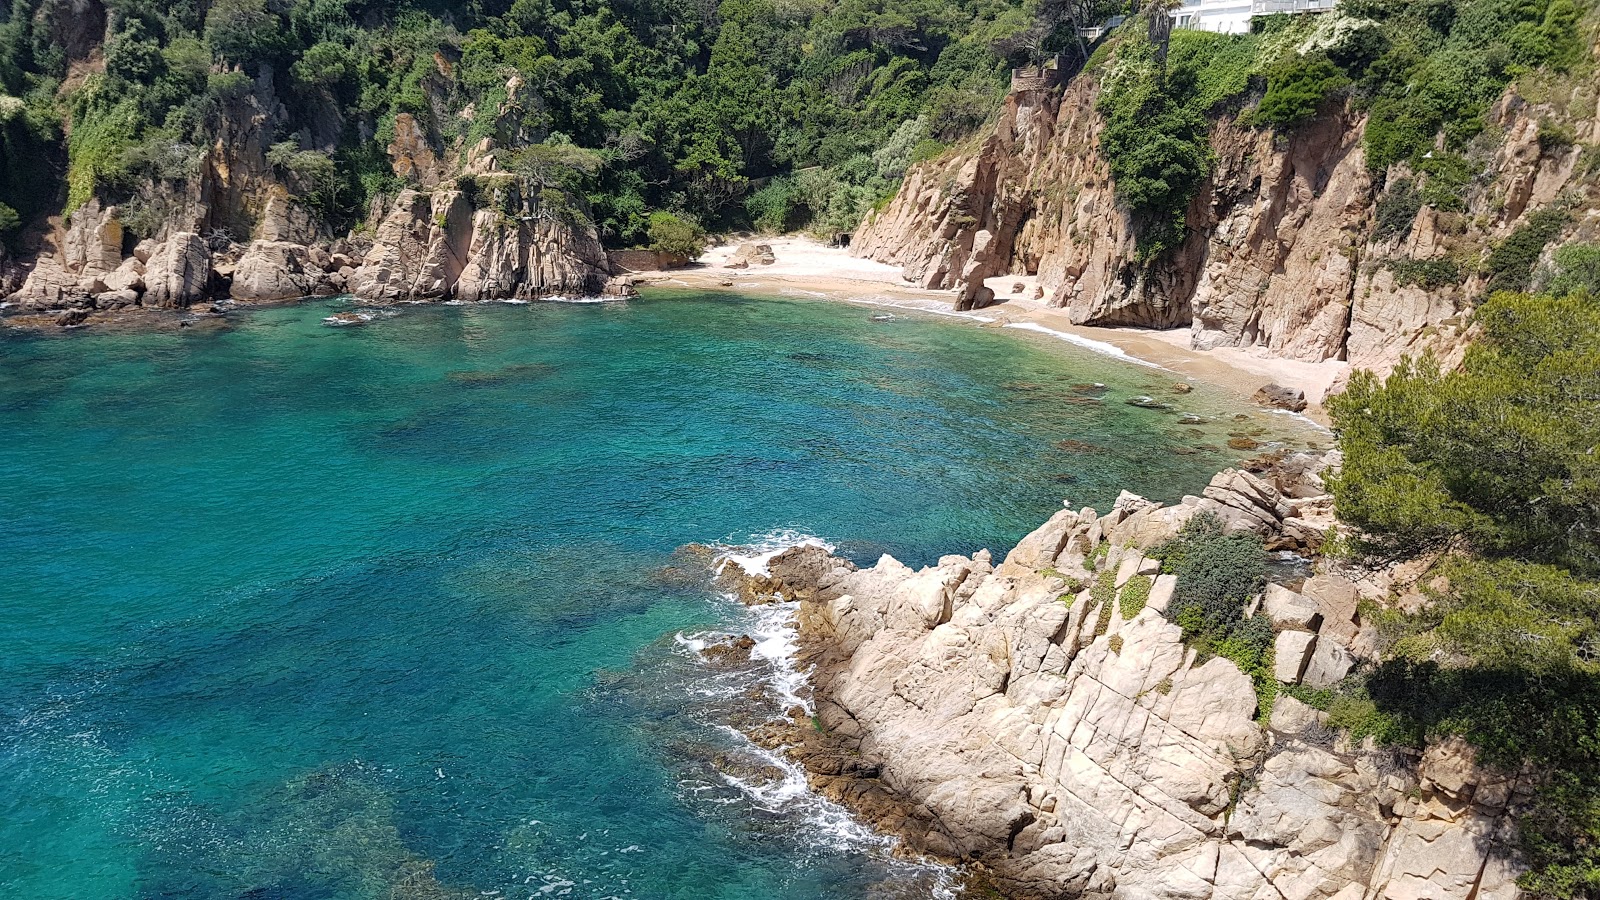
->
<box><xmin>1330</xmin><ymin>281</ymin><xmax>1600</xmax><ymax>898</ymax></box>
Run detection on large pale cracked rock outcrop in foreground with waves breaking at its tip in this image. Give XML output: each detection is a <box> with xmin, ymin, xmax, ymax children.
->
<box><xmin>726</xmin><ymin>454</ymin><xmax>1523</xmax><ymax>900</ymax></box>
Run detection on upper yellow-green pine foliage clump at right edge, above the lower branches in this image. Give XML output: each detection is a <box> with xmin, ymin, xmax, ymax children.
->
<box><xmin>1330</xmin><ymin>293</ymin><xmax>1600</xmax><ymax>573</ymax></box>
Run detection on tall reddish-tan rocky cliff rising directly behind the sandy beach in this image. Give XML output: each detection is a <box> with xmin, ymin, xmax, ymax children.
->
<box><xmin>851</xmin><ymin>58</ymin><xmax>1600</xmax><ymax>370</ymax></box>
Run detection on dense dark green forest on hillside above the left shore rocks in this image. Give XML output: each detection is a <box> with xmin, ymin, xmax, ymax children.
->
<box><xmin>0</xmin><ymin>0</ymin><xmax>1032</xmax><ymax>245</ymax></box>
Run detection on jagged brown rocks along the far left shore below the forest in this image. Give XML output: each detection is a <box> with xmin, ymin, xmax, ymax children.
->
<box><xmin>6</xmin><ymin>56</ymin><xmax>610</xmax><ymax>325</ymax></box>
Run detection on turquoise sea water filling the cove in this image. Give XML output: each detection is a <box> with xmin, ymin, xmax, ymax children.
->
<box><xmin>0</xmin><ymin>291</ymin><xmax>1315</xmax><ymax>900</ymax></box>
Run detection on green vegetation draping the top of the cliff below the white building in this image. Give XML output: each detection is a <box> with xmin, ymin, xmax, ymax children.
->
<box><xmin>1096</xmin><ymin>0</ymin><xmax>1595</xmax><ymax>259</ymax></box>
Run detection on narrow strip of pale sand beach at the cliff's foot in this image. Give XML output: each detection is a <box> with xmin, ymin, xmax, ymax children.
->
<box><xmin>650</xmin><ymin>237</ymin><xmax>1347</xmax><ymax>423</ymax></box>
